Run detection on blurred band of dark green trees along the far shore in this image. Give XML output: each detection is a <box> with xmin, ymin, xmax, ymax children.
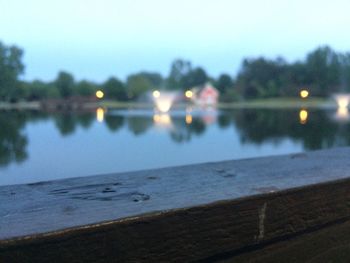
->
<box><xmin>0</xmin><ymin>42</ymin><xmax>350</xmax><ymax>102</ymax></box>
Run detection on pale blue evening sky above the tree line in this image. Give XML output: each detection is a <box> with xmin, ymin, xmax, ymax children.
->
<box><xmin>0</xmin><ymin>0</ymin><xmax>350</xmax><ymax>82</ymax></box>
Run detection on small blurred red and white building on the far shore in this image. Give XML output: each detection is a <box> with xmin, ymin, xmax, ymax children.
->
<box><xmin>192</xmin><ymin>83</ymin><xmax>219</xmax><ymax>105</ymax></box>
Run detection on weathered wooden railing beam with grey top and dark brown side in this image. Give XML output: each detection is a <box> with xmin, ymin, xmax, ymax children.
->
<box><xmin>0</xmin><ymin>148</ymin><xmax>350</xmax><ymax>262</ymax></box>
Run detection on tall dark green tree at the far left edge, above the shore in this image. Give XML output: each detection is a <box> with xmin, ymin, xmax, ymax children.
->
<box><xmin>0</xmin><ymin>42</ymin><xmax>24</xmax><ymax>101</ymax></box>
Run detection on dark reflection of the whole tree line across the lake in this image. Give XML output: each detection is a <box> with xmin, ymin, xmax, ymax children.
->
<box><xmin>0</xmin><ymin>108</ymin><xmax>350</xmax><ymax>170</ymax></box>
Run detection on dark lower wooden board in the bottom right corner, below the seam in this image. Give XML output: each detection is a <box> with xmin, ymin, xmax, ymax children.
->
<box><xmin>218</xmin><ymin>221</ymin><xmax>350</xmax><ymax>263</ymax></box>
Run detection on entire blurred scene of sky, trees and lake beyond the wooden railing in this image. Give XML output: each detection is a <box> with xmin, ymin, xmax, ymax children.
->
<box><xmin>0</xmin><ymin>0</ymin><xmax>350</xmax><ymax>184</ymax></box>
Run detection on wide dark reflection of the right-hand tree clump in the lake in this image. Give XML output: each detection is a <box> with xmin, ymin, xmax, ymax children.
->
<box><xmin>226</xmin><ymin>110</ymin><xmax>338</xmax><ymax>150</ymax></box>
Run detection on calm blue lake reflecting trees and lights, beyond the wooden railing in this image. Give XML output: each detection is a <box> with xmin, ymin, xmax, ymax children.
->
<box><xmin>0</xmin><ymin>106</ymin><xmax>350</xmax><ymax>185</ymax></box>
